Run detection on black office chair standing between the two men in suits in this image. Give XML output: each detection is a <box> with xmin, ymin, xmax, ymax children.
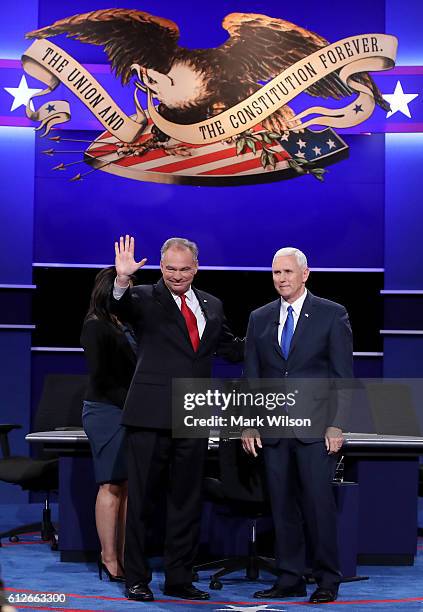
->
<box><xmin>193</xmin><ymin>440</ymin><xmax>279</xmax><ymax>590</ymax></box>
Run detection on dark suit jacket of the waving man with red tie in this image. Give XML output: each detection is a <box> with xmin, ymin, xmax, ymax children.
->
<box><xmin>112</xmin><ymin>280</ymin><xmax>243</xmax><ymax>429</ymax></box>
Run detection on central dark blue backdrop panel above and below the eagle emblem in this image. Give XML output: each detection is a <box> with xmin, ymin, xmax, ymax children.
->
<box><xmin>21</xmin><ymin>0</ymin><xmax>385</xmax><ymax>268</ymax></box>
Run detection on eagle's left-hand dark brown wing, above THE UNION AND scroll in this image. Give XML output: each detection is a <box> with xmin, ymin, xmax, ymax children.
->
<box><xmin>26</xmin><ymin>9</ymin><xmax>179</xmax><ymax>83</ymax></box>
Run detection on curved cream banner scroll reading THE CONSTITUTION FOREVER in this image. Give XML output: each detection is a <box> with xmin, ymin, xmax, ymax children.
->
<box><xmin>148</xmin><ymin>34</ymin><xmax>398</xmax><ymax>144</ymax></box>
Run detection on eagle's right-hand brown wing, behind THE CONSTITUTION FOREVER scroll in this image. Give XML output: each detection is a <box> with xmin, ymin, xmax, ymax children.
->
<box><xmin>220</xmin><ymin>13</ymin><xmax>389</xmax><ymax>110</ymax></box>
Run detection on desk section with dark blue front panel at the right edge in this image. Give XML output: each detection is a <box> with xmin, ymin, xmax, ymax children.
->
<box><xmin>343</xmin><ymin>434</ymin><xmax>423</xmax><ymax>565</ymax></box>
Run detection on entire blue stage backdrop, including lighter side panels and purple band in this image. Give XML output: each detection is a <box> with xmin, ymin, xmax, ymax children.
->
<box><xmin>0</xmin><ymin>0</ymin><xmax>423</xmax><ymax>510</ymax></box>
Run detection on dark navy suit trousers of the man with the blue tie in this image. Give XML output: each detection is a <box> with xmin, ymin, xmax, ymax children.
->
<box><xmin>264</xmin><ymin>437</ymin><xmax>342</xmax><ymax>590</ymax></box>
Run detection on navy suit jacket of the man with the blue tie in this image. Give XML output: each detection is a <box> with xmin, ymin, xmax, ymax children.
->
<box><xmin>244</xmin><ymin>292</ymin><xmax>353</xmax><ymax>443</ymax></box>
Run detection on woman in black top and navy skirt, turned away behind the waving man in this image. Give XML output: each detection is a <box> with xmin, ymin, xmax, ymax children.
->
<box><xmin>81</xmin><ymin>267</ymin><xmax>136</xmax><ymax>580</ymax></box>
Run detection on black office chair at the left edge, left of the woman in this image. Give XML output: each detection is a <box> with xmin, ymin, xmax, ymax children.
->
<box><xmin>0</xmin><ymin>374</ymin><xmax>87</xmax><ymax>550</ymax></box>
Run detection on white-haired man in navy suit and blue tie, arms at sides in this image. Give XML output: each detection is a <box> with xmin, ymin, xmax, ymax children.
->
<box><xmin>242</xmin><ymin>247</ymin><xmax>353</xmax><ymax>603</ymax></box>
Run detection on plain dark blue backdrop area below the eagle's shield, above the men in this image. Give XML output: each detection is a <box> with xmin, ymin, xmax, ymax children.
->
<box><xmin>34</xmin><ymin>131</ymin><xmax>384</xmax><ymax>268</ymax></box>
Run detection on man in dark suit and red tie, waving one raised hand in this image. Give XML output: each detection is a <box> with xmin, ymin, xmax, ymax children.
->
<box><xmin>113</xmin><ymin>236</ymin><xmax>243</xmax><ymax>601</ymax></box>
